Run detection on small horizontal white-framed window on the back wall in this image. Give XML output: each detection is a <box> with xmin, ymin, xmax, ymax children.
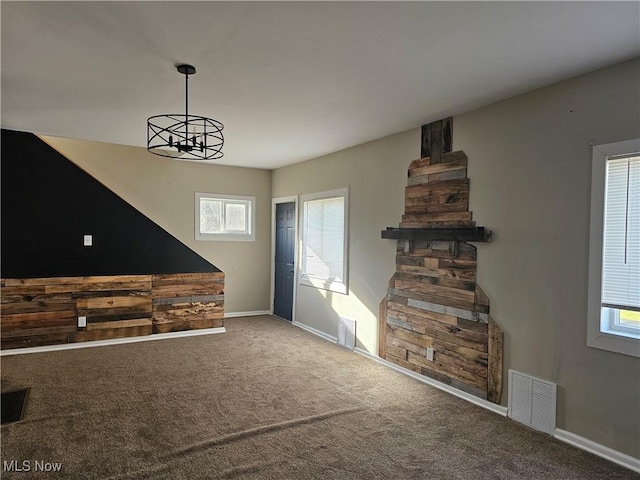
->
<box><xmin>195</xmin><ymin>193</ymin><xmax>256</xmax><ymax>241</ymax></box>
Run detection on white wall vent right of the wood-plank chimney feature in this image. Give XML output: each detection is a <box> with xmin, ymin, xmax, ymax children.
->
<box><xmin>509</xmin><ymin>370</ymin><xmax>557</xmax><ymax>435</ymax></box>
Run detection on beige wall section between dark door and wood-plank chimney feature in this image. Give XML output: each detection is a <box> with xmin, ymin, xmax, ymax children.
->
<box><xmin>271</xmin><ymin>130</ymin><xmax>420</xmax><ymax>354</ymax></box>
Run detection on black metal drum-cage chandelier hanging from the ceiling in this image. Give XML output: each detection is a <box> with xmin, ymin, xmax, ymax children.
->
<box><xmin>147</xmin><ymin>65</ymin><xmax>224</xmax><ymax>160</ymax></box>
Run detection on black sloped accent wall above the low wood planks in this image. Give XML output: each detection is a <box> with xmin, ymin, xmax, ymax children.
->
<box><xmin>0</xmin><ymin>130</ymin><xmax>220</xmax><ymax>278</ymax></box>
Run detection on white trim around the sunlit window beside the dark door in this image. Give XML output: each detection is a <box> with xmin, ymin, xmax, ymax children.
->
<box><xmin>298</xmin><ymin>188</ymin><xmax>349</xmax><ymax>295</ymax></box>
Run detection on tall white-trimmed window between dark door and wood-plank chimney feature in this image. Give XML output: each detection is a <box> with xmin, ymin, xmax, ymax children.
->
<box><xmin>300</xmin><ymin>188</ymin><xmax>349</xmax><ymax>293</ymax></box>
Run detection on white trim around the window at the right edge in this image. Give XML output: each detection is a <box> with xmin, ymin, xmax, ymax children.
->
<box><xmin>587</xmin><ymin>139</ymin><xmax>640</xmax><ymax>357</ymax></box>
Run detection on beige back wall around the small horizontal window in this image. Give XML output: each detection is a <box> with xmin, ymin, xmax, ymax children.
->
<box><xmin>43</xmin><ymin>137</ymin><xmax>271</xmax><ymax>313</ymax></box>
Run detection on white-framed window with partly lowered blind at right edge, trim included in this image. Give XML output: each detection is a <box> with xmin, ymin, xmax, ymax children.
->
<box><xmin>587</xmin><ymin>140</ymin><xmax>640</xmax><ymax>357</ymax></box>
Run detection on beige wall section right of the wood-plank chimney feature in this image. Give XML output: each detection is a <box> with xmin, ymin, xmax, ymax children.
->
<box><xmin>454</xmin><ymin>60</ymin><xmax>640</xmax><ymax>458</ymax></box>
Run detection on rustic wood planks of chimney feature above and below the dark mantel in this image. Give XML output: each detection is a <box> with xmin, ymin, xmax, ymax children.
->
<box><xmin>379</xmin><ymin>151</ymin><xmax>502</xmax><ymax>403</ymax></box>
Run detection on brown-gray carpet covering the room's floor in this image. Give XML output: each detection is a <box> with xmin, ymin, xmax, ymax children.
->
<box><xmin>1</xmin><ymin>316</ymin><xmax>640</xmax><ymax>480</ymax></box>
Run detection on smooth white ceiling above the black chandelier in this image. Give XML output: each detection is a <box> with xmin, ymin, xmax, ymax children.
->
<box><xmin>0</xmin><ymin>1</ymin><xmax>640</xmax><ymax>168</ymax></box>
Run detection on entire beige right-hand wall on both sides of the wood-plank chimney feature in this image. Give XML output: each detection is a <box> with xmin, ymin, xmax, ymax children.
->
<box><xmin>272</xmin><ymin>61</ymin><xmax>640</xmax><ymax>458</ymax></box>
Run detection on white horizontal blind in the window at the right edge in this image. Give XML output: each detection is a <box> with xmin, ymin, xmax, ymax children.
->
<box><xmin>602</xmin><ymin>156</ymin><xmax>640</xmax><ymax>311</ymax></box>
